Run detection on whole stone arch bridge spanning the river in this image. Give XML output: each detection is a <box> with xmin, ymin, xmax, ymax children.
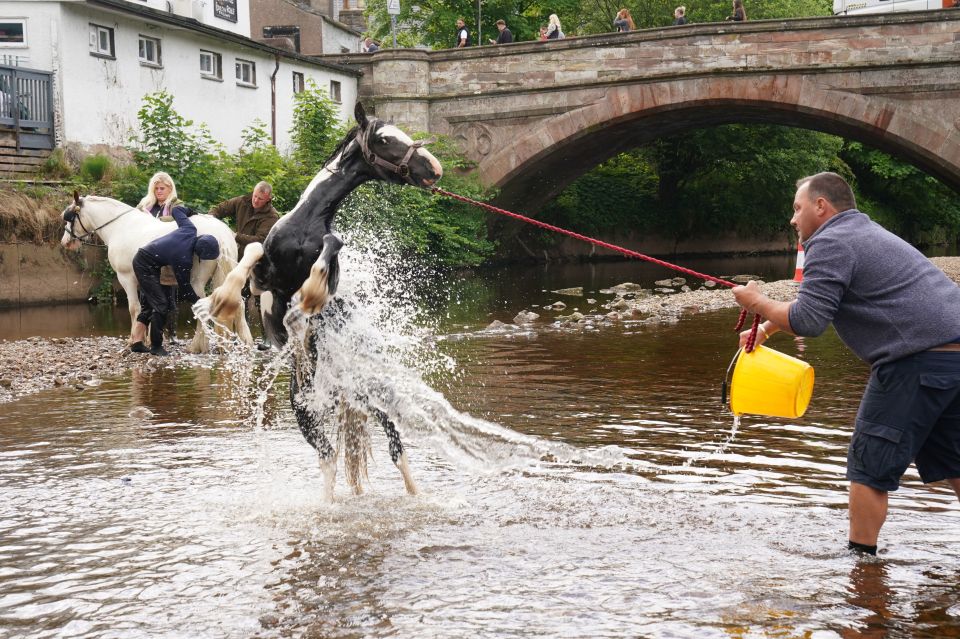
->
<box><xmin>338</xmin><ymin>10</ymin><xmax>960</xmax><ymax>210</ymax></box>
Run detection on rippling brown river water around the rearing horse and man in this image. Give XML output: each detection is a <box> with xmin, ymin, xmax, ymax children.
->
<box><xmin>0</xmin><ymin>256</ymin><xmax>960</xmax><ymax>638</ymax></box>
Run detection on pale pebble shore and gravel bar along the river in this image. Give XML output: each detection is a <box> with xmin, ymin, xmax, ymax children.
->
<box><xmin>0</xmin><ymin>257</ymin><xmax>960</xmax><ymax>404</ymax></box>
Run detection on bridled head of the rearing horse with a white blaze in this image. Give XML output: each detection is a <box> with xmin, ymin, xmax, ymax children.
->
<box><xmin>353</xmin><ymin>102</ymin><xmax>443</xmax><ymax>188</ymax></box>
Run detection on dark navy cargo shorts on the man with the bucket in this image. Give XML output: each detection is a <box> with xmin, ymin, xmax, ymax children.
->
<box><xmin>847</xmin><ymin>351</ymin><xmax>960</xmax><ymax>491</ymax></box>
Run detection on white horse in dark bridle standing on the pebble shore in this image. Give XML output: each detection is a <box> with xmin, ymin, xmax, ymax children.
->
<box><xmin>60</xmin><ymin>192</ymin><xmax>253</xmax><ymax>353</ymax></box>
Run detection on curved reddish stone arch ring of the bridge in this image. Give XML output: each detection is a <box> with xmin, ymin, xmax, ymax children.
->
<box><xmin>488</xmin><ymin>75</ymin><xmax>960</xmax><ymax>210</ymax></box>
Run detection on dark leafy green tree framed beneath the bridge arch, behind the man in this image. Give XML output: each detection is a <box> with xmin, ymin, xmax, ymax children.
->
<box><xmin>543</xmin><ymin>124</ymin><xmax>842</xmax><ymax>241</ymax></box>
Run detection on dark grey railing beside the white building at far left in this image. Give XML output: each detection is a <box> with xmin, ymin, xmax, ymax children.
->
<box><xmin>0</xmin><ymin>64</ymin><xmax>53</xmax><ymax>150</ymax></box>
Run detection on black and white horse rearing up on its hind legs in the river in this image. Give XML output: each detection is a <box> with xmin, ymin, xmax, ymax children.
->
<box><xmin>214</xmin><ymin>103</ymin><xmax>443</xmax><ymax>499</ymax></box>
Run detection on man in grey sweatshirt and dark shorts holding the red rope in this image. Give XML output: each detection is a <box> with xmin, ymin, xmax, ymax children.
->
<box><xmin>733</xmin><ymin>173</ymin><xmax>960</xmax><ymax>554</ymax></box>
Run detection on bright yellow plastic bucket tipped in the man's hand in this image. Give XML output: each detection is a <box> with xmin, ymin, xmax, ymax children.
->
<box><xmin>724</xmin><ymin>346</ymin><xmax>813</xmax><ymax>417</ymax></box>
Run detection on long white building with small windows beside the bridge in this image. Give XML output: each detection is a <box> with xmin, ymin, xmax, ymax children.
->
<box><xmin>0</xmin><ymin>0</ymin><xmax>358</xmax><ymax>151</ymax></box>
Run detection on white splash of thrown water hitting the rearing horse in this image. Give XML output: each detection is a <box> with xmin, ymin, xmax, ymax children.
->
<box><xmin>228</xmin><ymin>225</ymin><xmax>646</xmax><ymax>472</ymax></box>
